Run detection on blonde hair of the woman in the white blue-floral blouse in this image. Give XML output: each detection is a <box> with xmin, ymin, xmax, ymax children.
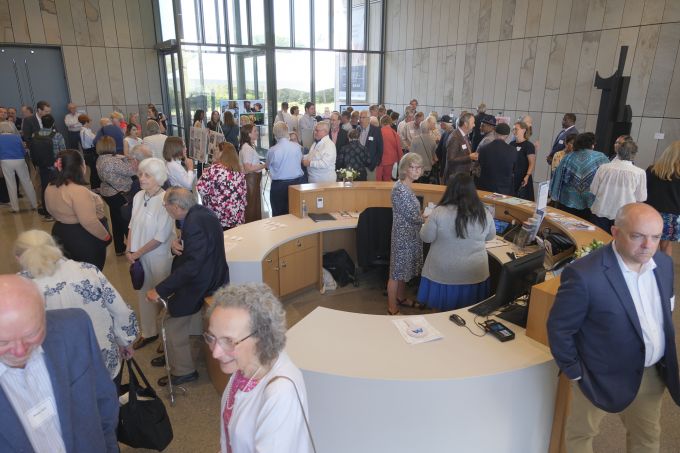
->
<box><xmin>14</xmin><ymin>230</ymin><xmax>64</xmax><ymax>278</ymax></box>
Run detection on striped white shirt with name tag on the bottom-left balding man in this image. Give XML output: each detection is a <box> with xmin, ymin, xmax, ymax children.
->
<box><xmin>0</xmin><ymin>346</ymin><xmax>66</xmax><ymax>453</ymax></box>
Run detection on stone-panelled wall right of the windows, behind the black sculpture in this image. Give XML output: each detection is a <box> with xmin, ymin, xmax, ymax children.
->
<box><xmin>384</xmin><ymin>0</ymin><xmax>680</xmax><ymax>181</ymax></box>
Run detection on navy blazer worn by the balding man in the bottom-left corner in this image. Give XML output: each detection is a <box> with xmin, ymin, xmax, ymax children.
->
<box><xmin>0</xmin><ymin>308</ymin><xmax>119</xmax><ymax>453</ymax></box>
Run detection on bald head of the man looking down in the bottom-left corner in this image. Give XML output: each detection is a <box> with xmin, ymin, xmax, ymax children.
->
<box><xmin>0</xmin><ymin>275</ymin><xmax>46</xmax><ymax>368</ymax></box>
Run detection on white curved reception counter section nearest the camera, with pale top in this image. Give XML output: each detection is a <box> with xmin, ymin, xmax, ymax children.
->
<box><xmin>287</xmin><ymin>307</ymin><xmax>557</xmax><ymax>453</ymax></box>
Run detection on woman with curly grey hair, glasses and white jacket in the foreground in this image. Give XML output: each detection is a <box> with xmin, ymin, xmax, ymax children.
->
<box><xmin>203</xmin><ymin>283</ymin><xmax>314</xmax><ymax>453</ymax></box>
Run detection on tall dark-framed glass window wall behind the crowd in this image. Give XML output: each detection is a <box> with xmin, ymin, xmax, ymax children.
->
<box><xmin>164</xmin><ymin>0</ymin><xmax>385</xmax><ymax>139</ymax></box>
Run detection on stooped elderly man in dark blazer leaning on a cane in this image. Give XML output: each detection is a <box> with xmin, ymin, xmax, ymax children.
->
<box><xmin>147</xmin><ymin>187</ymin><xmax>229</xmax><ymax>386</ymax></box>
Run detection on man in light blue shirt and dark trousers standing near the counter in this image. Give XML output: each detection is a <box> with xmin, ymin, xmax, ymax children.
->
<box><xmin>267</xmin><ymin>121</ymin><xmax>304</xmax><ymax>216</ymax></box>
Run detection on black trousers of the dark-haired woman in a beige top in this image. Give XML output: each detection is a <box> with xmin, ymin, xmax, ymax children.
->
<box><xmin>52</xmin><ymin>222</ymin><xmax>108</xmax><ymax>270</ymax></box>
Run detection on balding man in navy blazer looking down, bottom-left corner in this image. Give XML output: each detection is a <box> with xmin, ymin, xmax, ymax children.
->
<box><xmin>0</xmin><ymin>275</ymin><xmax>119</xmax><ymax>453</ymax></box>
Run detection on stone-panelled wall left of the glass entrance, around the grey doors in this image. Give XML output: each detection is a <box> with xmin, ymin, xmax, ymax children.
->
<box><xmin>0</xmin><ymin>0</ymin><xmax>162</xmax><ymax>131</ymax></box>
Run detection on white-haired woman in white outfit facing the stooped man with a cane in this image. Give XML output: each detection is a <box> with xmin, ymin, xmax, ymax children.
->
<box><xmin>125</xmin><ymin>157</ymin><xmax>175</xmax><ymax>349</ymax></box>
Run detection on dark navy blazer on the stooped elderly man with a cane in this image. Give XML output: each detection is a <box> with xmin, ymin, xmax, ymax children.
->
<box><xmin>156</xmin><ymin>205</ymin><xmax>229</xmax><ymax>318</ymax></box>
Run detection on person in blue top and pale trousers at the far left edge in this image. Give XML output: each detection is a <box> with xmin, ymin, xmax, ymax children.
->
<box><xmin>0</xmin><ymin>121</ymin><xmax>38</xmax><ymax>213</ymax></box>
